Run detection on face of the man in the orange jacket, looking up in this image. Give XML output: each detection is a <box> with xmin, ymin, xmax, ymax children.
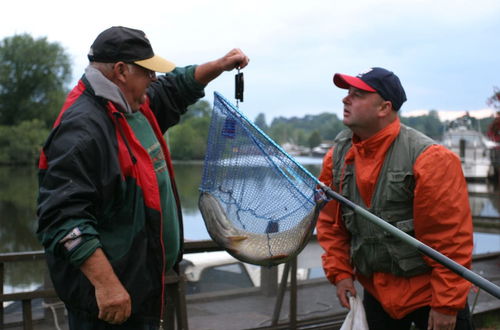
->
<box><xmin>342</xmin><ymin>87</ymin><xmax>384</xmax><ymax>136</ymax></box>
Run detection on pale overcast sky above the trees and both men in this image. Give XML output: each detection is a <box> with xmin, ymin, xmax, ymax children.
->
<box><xmin>0</xmin><ymin>0</ymin><xmax>500</xmax><ymax>122</ymax></box>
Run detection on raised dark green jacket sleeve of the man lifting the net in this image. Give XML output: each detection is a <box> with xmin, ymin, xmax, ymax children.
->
<box><xmin>148</xmin><ymin>65</ymin><xmax>205</xmax><ymax>134</ymax></box>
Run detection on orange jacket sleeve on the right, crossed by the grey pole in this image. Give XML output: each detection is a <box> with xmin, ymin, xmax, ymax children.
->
<box><xmin>414</xmin><ymin>145</ymin><xmax>473</xmax><ymax>314</ymax></box>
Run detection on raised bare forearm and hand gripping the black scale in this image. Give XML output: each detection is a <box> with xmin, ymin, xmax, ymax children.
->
<box><xmin>194</xmin><ymin>48</ymin><xmax>250</xmax><ymax>85</ymax></box>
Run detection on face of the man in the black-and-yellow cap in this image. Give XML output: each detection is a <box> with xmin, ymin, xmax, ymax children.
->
<box><xmin>124</xmin><ymin>64</ymin><xmax>156</xmax><ymax>111</ymax></box>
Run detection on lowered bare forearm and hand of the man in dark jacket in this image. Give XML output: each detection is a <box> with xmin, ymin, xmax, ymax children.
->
<box><xmin>80</xmin><ymin>249</ymin><xmax>132</xmax><ymax>324</ymax></box>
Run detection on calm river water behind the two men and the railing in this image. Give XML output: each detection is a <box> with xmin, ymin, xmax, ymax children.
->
<box><xmin>0</xmin><ymin>157</ymin><xmax>500</xmax><ymax>292</ymax></box>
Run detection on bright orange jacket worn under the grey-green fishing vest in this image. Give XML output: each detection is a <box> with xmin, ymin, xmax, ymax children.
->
<box><xmin>317</xmin><ymin>120</ymin><xmax>473</xmax><ymax>319</ymax></box>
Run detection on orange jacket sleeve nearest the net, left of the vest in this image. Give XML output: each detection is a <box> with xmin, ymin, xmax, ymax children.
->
<box><xmin>316</xmin><ymin>149</ymin><xmax>354</xmax><ymax>284</ymax></box>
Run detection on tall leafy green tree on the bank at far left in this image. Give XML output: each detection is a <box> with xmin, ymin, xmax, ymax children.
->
<box><xmin>0</xmin><ymin>34</ymin><xmax>71</xmax><ymax>164</ymax></box>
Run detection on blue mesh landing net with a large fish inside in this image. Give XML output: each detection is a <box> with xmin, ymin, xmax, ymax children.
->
<box><xmin>199</xmin><ymin>92</ymin><xmax>320</xmax><ymax>266</ymax></box>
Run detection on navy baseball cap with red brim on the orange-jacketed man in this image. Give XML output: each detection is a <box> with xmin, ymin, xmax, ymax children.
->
<box><xmin>333</xmin><ymin>67</ymin><xmax>406</xmax><ymax>111</ymax></box>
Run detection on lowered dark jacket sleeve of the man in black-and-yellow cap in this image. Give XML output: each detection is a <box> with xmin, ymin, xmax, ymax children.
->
<box><xmin>37</xmin><ymin>112</ymin><xmax>104</xmax><ymax>267</ymax></box>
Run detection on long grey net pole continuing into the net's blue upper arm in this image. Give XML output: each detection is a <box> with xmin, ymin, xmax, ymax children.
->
<box><xmin>214</xmin><ymin>92</ymin><xmax>500</xmax><ymax>299</ymax></box>
